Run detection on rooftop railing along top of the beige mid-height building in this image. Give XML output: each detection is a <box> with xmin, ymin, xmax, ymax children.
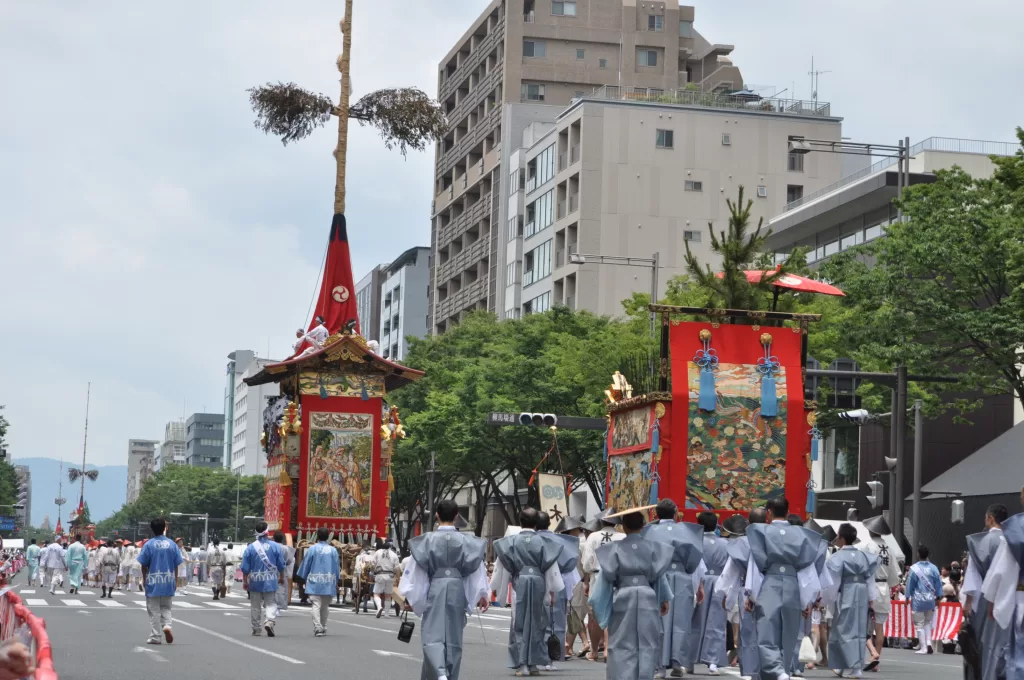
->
<box><xmin>585</xmin><ymin>85</ymin><xmax>831</xmax><ymax>118</ymax></box>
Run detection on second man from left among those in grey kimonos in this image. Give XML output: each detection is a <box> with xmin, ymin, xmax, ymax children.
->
<box><xmin>490</xmin><ymin>508</ymin><xmax>564</xmax><ymax>677</ymax></box>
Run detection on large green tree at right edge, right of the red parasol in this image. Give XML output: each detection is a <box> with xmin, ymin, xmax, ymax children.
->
<box><xmin>822</xmin><ymin>160</ymin><xmax>1024</xmax><ymax>409</ymax></box>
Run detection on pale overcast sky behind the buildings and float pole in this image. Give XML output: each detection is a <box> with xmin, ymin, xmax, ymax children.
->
<box><xmin>0</xmin><ymin>0</ymin><xmax>1024</xmax><ymax>465</ymax></box>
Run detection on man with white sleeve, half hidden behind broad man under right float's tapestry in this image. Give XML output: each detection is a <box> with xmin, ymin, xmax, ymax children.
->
<box><xmin>715</xmin><ymin>508</ymin><xmax>767</xmax><ymax>678</ymax></box>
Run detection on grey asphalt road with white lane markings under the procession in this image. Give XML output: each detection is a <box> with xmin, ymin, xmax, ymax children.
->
<box><xmin>16</xmin><ymin>586</ymin><xmax>962</xmax><ymax>680</ymax></box>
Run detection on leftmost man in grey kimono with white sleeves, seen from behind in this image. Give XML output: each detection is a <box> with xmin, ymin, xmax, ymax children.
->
<box><xmin>398</xmin><ymin>499</ymin><xmax>489</xmax><ymax>680</ymax></box>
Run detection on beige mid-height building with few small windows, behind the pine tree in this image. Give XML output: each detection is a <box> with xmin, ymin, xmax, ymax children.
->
<box><xmin>497</xmin><ymin>87</ymin><xmax>842</xmax><ymax>318</ymax></box>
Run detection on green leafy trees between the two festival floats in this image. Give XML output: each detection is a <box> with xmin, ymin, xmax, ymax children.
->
<box><xmin>392</xmin><ymin>307</ymin><xmax>651</xmax><ymax>530</ymax></box>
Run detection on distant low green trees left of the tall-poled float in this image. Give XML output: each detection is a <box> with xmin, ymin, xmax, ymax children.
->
<box><xmin>96</xmin><ymin>465</ymin><xmax>265</xmax><ymax>539</ymax></box>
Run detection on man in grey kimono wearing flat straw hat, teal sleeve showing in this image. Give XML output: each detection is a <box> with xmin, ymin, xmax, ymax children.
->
<box><xmin>590</xmin><ymin>506</ymin><xmax>674</xmax><ymax>680</ymax></box>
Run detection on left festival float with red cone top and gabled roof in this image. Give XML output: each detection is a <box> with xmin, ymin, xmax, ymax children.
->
<box><xmin>246</xmin><ymin>215</ymin><xmax>423</xmax><ymax>552</ymax></box>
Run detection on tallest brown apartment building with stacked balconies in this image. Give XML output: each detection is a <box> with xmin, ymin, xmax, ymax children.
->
<box><xmin>427</xmin><ymin>0</ymin><xmax>743</xmax><ymax>333</ymax></box>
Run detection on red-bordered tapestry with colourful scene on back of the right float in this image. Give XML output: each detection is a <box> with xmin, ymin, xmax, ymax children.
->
<box><xmin>662</xmin><ymin>323</ymin><xmax>810</xmax><ymax>516</ymax></box>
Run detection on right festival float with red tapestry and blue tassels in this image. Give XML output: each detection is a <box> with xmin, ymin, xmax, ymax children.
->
<box><xmin>605</xmin><ymin>305</ymin><xmax>820</xmax><ymax>521</ymax></box>
